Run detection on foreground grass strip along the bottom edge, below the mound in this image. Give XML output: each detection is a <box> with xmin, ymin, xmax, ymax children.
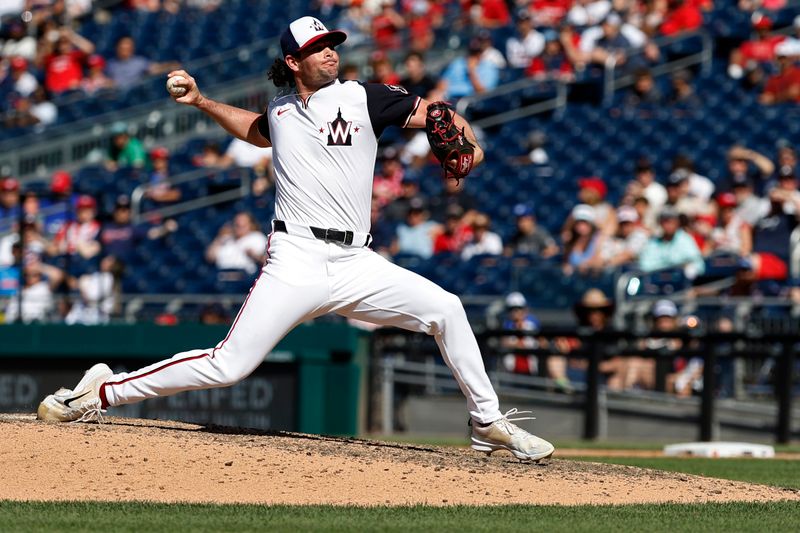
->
<box><xmin>0</xmin><ymin>498</ymin><xmax>800</xmax><ymax>533</ymax></box>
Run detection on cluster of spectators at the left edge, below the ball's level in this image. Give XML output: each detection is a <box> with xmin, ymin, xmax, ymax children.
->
<box><xmin>0</xmin><ymin>164</ymin><xmax>177</xmax><ymax>324</ymax></box>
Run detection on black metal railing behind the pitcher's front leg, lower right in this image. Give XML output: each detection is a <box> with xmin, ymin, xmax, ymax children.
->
<box><xmin>370</xmin><ymin>329</ymin><xmax>799</xmax><ymax>443</ymax></box>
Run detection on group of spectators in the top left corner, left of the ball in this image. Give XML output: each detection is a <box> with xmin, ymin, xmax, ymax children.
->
<box><xmin>0</xmin><ymin>0</ymin><xmax>178</xmax><ymax>132</ymax></box>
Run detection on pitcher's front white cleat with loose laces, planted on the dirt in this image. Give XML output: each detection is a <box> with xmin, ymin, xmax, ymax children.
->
<box><xmin>471</xmin><ymin>409</ymin><xmax>555</xmax><ymax>461</ymax></box>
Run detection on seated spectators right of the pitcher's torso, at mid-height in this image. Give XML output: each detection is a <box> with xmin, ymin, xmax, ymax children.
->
<box><xmin>373</xmin><ymin>136</ymin><xmax>800</xmax><ymax>281</ymax></box>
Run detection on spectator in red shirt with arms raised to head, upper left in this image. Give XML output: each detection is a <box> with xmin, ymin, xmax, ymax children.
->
<box><xmin>44</xmin><ymin>28</ymin><xmax>94</xmax><ymax>93</ymax></box>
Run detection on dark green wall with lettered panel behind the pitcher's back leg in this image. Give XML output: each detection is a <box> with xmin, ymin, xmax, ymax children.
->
<box><xmin>0</xmin><ymin>323</ymin><xmax>368</xmax><ymax>435</ymax></box>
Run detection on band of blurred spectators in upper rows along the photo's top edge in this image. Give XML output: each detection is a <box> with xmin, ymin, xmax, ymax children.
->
<box><xmin>0</xmin><ymin>0</ymin><xmax>800</xmax><ymax>139</ymax></box>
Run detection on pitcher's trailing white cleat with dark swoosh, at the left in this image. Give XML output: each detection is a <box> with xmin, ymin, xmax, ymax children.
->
<box><xmin>36</xmin><ymin>363</ymin><xmax>114</xmax><ymax>422</ymax></box>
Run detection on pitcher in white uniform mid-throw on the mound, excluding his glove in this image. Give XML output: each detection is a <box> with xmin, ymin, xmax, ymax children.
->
<box><xmin>37</xmin><ymin>16</ymin><xmax>555</xmax><ymax>461</ymax></box>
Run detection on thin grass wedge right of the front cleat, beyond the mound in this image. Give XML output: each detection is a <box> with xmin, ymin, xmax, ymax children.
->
<box><xmin>570</xmin><ymin>457</ymin><xmax>800</xmax><ymax>488</ymax></box>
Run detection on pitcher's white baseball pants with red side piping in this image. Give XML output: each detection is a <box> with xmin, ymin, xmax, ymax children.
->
<box><xmin>100</xmin><ymin>232</ymin><xmax>502</xmax><ymax>423</ymax></box>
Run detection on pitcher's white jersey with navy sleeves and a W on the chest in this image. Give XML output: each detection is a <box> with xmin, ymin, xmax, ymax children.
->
<box><xmin>258</xmin><ymin>80</ymin><xmax>420</xmax><ymax>233</ymax></box>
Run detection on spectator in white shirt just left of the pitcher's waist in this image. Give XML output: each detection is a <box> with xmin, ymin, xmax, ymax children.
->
<box><xmin>206</xmin><ymin>212</ymin><xmax>267</xmax><ymax>274</ymax></box>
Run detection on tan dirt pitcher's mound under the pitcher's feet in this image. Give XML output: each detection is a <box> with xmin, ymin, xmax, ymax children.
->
<box><xmin>0</xmin><ymin>415</ymin><xmax>800</xmax><ymax>505</ymax></box>
